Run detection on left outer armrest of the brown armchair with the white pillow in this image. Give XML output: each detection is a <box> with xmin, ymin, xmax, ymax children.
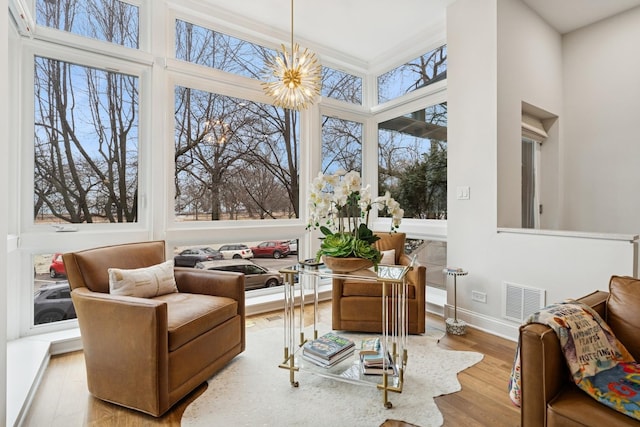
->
<box><xmin>71</xmin><ymin>287</ymin><xmax>169</xmax><ymax>411</ymax></box>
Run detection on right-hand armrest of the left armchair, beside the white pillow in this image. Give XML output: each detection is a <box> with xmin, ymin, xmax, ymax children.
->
<box><xmin>174</xmin><ymin>267</ymin><xmax>245</xmax><ymax>318</ymax></box>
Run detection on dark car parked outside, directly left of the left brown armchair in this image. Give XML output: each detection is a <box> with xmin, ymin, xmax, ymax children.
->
<box><xmin>33</xmin><ymin>282</ymin><xmax>76</xmax><ymax>325</ymax></box>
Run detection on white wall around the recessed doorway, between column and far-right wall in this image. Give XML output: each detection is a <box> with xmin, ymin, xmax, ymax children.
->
<box><xmin>497</xmin><ymin>0</ymin><xmax>562</xmax><ymax>228</ymax></box>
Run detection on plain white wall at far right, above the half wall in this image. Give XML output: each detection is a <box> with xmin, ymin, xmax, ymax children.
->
<box><xmin>563</xmin><ymin>8</ymin><xmax>640</xmax><ymax>233</ymax></box>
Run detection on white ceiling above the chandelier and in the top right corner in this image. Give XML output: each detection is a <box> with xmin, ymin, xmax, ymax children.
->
<box><xmin>200</xmin><ymin>0</ymin><xmax>640</xmax><ymax>64</ymax></box>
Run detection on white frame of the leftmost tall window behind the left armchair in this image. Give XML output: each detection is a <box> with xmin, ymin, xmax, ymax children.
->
<box><xmin>16</xmin><ymin>39</ymin><xmax>153</xmax><ymax>336</ymax></box>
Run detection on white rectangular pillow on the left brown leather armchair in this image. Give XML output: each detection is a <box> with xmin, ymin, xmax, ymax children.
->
<box><xmin>108</xmin><ymin>260</ymin><xmax>178</xmax><ymax>298</ymax></box>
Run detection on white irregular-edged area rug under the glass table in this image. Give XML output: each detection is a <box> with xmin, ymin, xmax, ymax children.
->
<box><xmin>182</xmin><ymin>328</ymin><xmax>483</xmax><ymax>427</ymax></box>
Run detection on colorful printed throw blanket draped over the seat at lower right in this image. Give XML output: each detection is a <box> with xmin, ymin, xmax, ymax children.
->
<box><xmin>509</xmin><ymin>301</ymin><xmax>640</xmax><ymax>419</ymax></box>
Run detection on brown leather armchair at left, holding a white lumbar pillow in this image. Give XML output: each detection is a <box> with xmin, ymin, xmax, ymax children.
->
<box><xmin>63</xmin><ymin>241</ymin><xmax>245</xmax><ymax>417</ymax></box>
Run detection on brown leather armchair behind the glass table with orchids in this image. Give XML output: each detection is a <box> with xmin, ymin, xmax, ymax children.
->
<box><xmin>331</xmin><ymin>232</ymin><xmax>427</xmax><ymax>334</ymax></box>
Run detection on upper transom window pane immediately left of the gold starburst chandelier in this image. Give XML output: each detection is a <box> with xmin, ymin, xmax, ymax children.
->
<box><xmin>176</xmin><ymin>20</ymin><xmax>277</xmax><ymax>79</ymax></box>
